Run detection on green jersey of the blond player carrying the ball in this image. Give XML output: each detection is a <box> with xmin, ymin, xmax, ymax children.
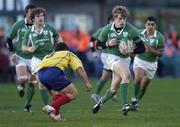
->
<box><xmin>98</xmin><ymin>22</ymin><xmax>139</xmax><ymax>58</ymax></box>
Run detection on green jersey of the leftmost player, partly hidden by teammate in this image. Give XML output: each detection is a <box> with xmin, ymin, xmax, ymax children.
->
<box><xmin>8</xmin><ymin>19</ymin><xmax>32</xmax><ymax>59</ymax></box>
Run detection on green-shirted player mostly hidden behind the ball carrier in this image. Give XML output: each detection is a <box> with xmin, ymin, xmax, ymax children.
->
<box><xmin>90</xmin><ymin>16</ymin><xmax>117</xmax><ymax>103</ymax></box>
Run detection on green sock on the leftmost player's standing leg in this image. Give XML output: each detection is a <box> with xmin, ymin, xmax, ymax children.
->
<box><xmin>25</xmin><ymin>85</ymin><xmax>35</xmax><ymax>105</ymax></box>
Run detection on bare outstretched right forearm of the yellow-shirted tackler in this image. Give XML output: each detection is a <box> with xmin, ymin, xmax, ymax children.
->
<box><xmin>76</xmin><ymin>67</ymin><xmax>92</xmax><ymax>91</ymax></box>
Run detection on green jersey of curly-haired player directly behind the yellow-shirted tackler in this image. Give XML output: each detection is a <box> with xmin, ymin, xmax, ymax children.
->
<box><xmin>23</xmin><ymin>24</ymin><xmax>59</xmax><ymax>60</ymax></box>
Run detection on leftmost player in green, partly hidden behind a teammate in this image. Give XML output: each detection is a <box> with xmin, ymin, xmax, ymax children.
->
<box><xmin>7</xmin><ymin>5</ymin><xmax>37</xmax><ymax>112</ymax></box>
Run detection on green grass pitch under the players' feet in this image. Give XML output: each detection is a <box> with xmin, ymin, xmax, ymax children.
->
<box><xmin>0</xmin><ymin>79</ymin><xmax>180</xmax><ymax>127</ymax></box>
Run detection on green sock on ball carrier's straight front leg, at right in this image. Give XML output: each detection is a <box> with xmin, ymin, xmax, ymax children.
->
<box><xmin>120</xmin><ymin>83</ymin><xmax>128</xmax><ymax>105</ymax></box>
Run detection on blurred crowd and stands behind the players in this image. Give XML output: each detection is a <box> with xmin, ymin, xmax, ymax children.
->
<box><xmin>0</xmin><ymin>0</ymin><xmax>180</xmax><ymax>83</ymax></box>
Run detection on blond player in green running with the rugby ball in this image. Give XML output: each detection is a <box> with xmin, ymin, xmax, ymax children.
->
<box><xmin>93</xmin><ymin>6</ymin><xmax>145</xmax><ymax>115</ymax></box>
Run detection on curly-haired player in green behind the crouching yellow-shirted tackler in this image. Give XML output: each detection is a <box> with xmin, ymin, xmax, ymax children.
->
<box><xmin>22</xmin><ymin>8</ymin><xmax>62</xmax><ymax>105</ymax></box>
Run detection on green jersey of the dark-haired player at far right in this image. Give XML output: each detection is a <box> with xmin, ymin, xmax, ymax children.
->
<box><xmin>137</xmin><ymin>29</ymin><xmax>165</xmax><ymax>62</ymax></box>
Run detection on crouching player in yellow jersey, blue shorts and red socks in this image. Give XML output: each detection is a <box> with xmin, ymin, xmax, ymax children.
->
<box><xmin>38</xmin><ymin>43</ymin><xmax>92</xmax><ymax>121</ymax></box>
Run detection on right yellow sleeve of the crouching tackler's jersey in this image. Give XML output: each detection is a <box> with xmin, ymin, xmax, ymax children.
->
<box><xmin>69</xmin><ymin>53</ymin><xmax>83</xmax><ymax>71</ymax></box>
